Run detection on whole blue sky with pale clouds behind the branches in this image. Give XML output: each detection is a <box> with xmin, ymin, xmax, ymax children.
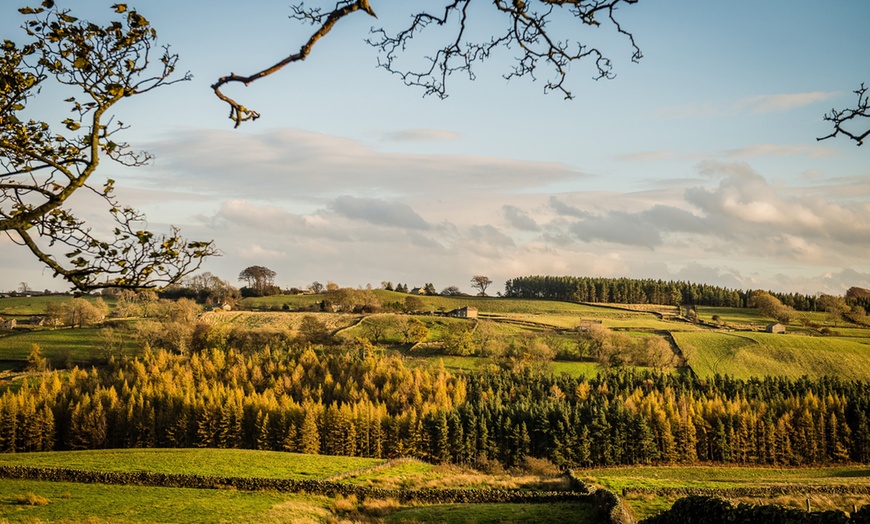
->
<box><xmin>0</xmin><ymin>0</ymin><xmax>870</xmax><ymax>295</ymax></box>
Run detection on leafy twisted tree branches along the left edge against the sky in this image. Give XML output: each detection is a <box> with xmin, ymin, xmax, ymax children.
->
<box><xmin>0</xmin><ymin>0</ymin><xmax>215</xmax><ymax>290</ymax></box>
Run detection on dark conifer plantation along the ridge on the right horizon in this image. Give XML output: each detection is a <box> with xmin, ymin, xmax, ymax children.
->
<box><xmin>505</xmin><ymin>276</ymin><xmax>817</xmax><ymax>311</ymax></box>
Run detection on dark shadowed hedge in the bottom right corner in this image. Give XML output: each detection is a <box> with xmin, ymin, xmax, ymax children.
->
<box><xmin>641</xmin><ymin>496</ymin><xmax>870</xmax><ymax>524</ymax></box>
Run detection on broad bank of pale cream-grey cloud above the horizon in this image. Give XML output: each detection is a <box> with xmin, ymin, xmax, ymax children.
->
<box><xmin>0</xmin><ymin>131</ymin><xmax>870</xmax><ymax>293</ymax></box>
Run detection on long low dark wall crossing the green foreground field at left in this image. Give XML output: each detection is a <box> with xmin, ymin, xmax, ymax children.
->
<box><xmin>0</xmin><ymin>466</ymin><xmax>592</xmax><ymax>504</ymax></box>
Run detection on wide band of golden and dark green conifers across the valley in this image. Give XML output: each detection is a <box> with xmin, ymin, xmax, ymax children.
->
<box><xmin>0</xmin><ymin>337</ymin><xmax>870</xmax><ymax>467</ymax></box>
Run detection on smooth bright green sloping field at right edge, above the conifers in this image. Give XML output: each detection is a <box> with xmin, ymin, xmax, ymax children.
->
<box><xmin>673</xmin><ymin>331</ymin><xmax>870</xmax><ymax>380</ymax></box>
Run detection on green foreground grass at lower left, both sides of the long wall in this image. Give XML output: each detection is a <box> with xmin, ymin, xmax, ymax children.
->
<box><xmin>0</xmin><ymin>449</ymin><xmax>601</xmax><ymax>524</ymax></box>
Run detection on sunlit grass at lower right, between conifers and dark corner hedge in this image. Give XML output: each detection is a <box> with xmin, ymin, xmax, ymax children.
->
<box><xmin>575</xmin><ymin>466</ymin><xmax>870</xmax><ymax>518</ymax></box>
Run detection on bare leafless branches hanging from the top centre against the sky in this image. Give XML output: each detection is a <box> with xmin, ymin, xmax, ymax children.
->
<box><xmin>212</xmin><ymin>0</ymin><xmax>643</xmax><ymax>127</ymax></box>
